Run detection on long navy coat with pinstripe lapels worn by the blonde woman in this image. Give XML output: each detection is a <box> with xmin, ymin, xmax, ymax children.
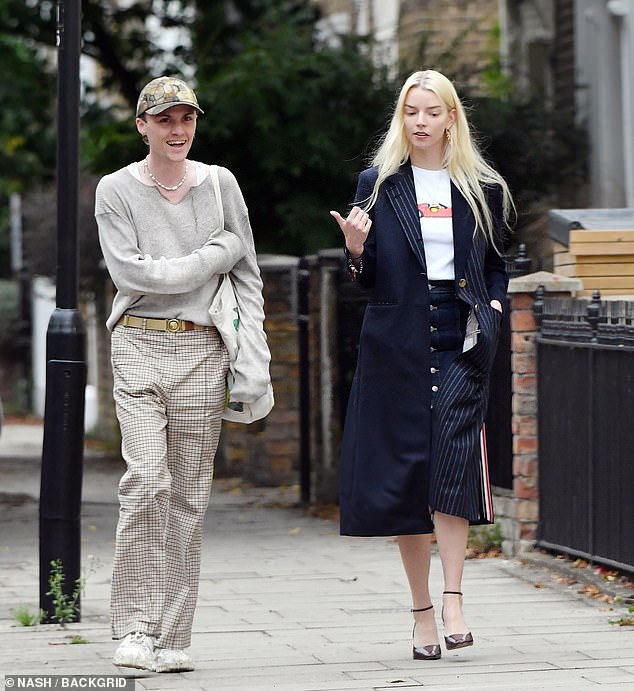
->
<box><xmin>340</xmin><ymin>164</ymin><xmax>508</xmax><ymax>536</ymax></box>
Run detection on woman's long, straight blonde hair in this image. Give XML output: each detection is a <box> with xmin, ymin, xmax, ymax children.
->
<box><xmin>364</xmin><ymin>70</ymin><xmax>515</xmax><ymax>242</ymax></box>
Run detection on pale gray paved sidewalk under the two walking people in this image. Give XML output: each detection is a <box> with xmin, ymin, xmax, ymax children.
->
<box><xmin>0</xmin><ymin>425</ymin><xmax>634</xmax><ymax>691</ymax></box>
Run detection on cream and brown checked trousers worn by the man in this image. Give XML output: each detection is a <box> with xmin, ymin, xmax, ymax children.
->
<box><xmin>111</xmin><ymin>326</ymin><xmax>229</xmax><ymax>649</ymax></box>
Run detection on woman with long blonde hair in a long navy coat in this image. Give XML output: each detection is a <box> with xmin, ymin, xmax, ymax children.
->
<box><xmin>331</xmin><ymin>70</ymin><xmax>513</xmax><ymax>660</ymax></box>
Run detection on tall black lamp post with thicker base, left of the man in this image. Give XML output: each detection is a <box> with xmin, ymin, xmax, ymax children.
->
<box><xmin>40</xmin><ymin>0</ymin><xmax>86</xmax><ymax>622</ymax></box>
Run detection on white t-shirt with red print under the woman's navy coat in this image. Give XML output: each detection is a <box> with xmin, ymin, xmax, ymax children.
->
<box><xmin>412</xmin><ymin>166</ymin><xmax>455</xmax><ymax>281</ymax></box>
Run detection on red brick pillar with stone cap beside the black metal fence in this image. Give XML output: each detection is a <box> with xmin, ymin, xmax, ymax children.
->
<box><xmin>508</xmin><ymin>271</ymin><xmax>583</xmax><ymax>556</ymax></box>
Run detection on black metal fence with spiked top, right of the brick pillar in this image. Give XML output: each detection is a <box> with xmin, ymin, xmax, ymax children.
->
<box><xmin>535</xmin><ymin>292</ymin><xmax>634</xmax><ymax>573</ymax></box>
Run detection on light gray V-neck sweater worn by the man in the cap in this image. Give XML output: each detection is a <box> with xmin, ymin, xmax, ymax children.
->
<box><xmin>95</xmin><ymin>162</ymin><xmax>270</xmax><ymax>401</ymax></box>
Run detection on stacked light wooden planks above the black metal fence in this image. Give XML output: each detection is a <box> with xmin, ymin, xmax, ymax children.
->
<box><xmin>553</xmin><ymin>228</ymin><xmax>634</xmax><ymax>296</ymax></box>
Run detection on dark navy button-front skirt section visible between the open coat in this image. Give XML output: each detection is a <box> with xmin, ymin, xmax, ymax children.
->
<box><xmin>429</xmin><ymin>281</ymin><xmax>469</xmax><ymax>407</ymax></box>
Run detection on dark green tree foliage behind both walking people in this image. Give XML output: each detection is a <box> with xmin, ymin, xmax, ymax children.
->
<box><xmin>0</xmin><ymin>0</ymin><xmax>583</xmax><ymax>275</ymax></box>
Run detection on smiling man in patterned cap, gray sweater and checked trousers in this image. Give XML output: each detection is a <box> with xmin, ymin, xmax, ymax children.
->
<box><xmin>95</xmin><ymin>77</ymin><xmax>270</xmax><ymax>672</ymax></box>
